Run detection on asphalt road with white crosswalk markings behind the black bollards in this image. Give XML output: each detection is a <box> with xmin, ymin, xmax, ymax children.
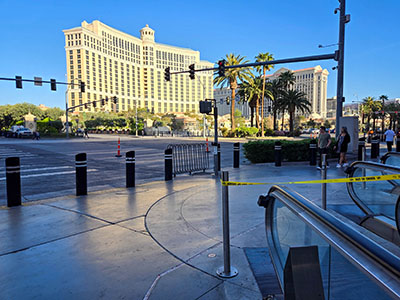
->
<box><xmin>0</xmin><ymin>135</ymin><xmax>245</xmax><ymax>205</ymax></box>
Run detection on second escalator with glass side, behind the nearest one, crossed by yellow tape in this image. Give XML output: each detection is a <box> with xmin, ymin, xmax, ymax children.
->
<box><xmin>341</xmin><ymin>162</ymin><xmax>400</xmax><ymax>245</ymax></box>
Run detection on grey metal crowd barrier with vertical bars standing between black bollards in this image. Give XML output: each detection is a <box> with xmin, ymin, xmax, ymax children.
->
<box><xmin>167</xmin><ymin>143</ymin><xmax>210</xmax><ymax>176</ymax></box>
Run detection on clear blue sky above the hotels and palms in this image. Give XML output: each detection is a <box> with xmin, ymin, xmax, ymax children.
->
<box><xmin>0</xmin><ymin>0</ymin><xmax>400</xmax><ymax>107</ymax></box>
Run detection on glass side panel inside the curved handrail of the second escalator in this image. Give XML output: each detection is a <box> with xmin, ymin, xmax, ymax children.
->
<box><xmin>353</xmin><ymin>167</ymin><xmax>399</xmax><ymax>218</ymax></box>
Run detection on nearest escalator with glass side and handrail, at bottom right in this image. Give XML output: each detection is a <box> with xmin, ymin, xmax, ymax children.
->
<box><xmin>259</xmin><ymin>186</ymin><xmax>400</xmax><ymax>299</ymax></box>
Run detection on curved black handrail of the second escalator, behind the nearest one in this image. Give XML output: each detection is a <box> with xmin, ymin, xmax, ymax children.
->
<box><xmin>346</xmin><ymin>161</ymin><xmax>400</xmax><ymax>215</ymax></box>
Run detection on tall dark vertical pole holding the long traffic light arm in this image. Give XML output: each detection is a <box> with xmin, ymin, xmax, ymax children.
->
<box><xmin>336</xmin><ymin>0</ymin><xmax>346</xmax><ymax>138</ymax></box>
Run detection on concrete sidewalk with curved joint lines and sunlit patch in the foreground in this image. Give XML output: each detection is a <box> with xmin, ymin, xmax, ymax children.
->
<box><xmin>0</xmin><ymin>163</ymin><xmax>351</xmax><ymax>299</ymax></box>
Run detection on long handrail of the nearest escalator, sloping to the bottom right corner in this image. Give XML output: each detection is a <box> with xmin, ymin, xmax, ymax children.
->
<box><xmin>266</xmin><ymin>185</ymin><xmax>400</xmax><ymax>297</ymax></box>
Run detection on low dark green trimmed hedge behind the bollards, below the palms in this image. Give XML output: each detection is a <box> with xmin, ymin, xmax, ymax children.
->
<box><xmin>243</xmin><ymin>139</ymin><xmax>338</xmax><ymax>163</ymax></box>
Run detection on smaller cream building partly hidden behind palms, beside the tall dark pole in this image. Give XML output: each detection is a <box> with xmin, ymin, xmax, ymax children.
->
<box><xmin>267</xmin><ymin>66</ymin><xmax>329</xmax><ymax>118</ymax></box>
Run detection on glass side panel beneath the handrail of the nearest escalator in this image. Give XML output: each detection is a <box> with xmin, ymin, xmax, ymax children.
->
<box><xmin>270</xmin><ymin>199</ymin><xmax>390</xmax><ymax>299</ymax></box>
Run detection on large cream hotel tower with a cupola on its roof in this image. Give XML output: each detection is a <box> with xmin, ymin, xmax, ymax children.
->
<box><xmin>63</xmin><ymin>20</ymin><xmax>214</xmax><ymax>113</ymax></box>
